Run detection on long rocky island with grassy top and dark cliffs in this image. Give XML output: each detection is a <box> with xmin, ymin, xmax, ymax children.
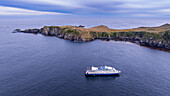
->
<box><xmin>13</xmin><ymin>24</ymin><xmax>170</xmax><ymax>52</ymax></box>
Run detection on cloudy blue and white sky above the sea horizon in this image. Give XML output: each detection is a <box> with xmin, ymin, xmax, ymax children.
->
<box><xmin>0</xmin><ymin>0</ymin><xmax>170</xmax><ymax>17</ymax></box>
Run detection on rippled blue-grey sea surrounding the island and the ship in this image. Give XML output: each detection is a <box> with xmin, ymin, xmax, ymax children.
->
<box><xmin>0</xmin><ymin>18</ymin><xmax>170</xmax><ymax>96</ymax></box>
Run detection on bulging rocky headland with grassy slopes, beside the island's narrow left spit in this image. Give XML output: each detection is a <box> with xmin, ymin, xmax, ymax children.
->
<box><xmin>41</xmin><ymin>26</ymin><xmax>92</xmax><ymax>42</ymax></box>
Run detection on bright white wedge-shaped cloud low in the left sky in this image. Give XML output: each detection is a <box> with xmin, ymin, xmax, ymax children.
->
<box><xmin>0</xmin><ymin>6</ymin><xmax>64</xmax><ymax>15</ymax></box>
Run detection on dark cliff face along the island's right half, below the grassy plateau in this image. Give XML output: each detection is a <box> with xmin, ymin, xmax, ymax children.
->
<box><xmin>90</xmin><ymin>31</ymin><xmax>170</xmax><ymax>49</ymax></box>
